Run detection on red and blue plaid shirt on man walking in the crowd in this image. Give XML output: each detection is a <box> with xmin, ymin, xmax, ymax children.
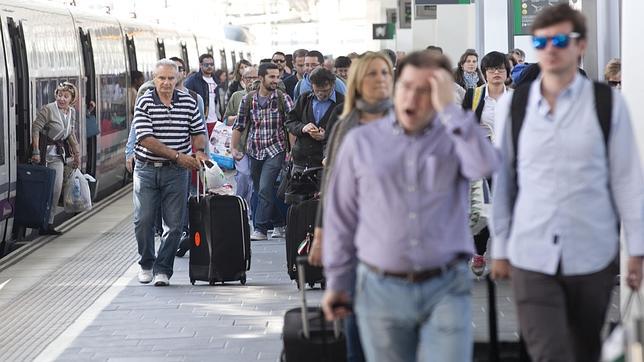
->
<box><xmin>233</xmin><ymin>91</ymin><xmax>295</xmax><ymax>160</ymax></box>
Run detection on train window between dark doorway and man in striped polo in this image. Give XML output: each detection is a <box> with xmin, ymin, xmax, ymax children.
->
<box><xmin>98</xmin><ymin>73</ymin><xmax>127</xmax><ymax>136</ymax></box>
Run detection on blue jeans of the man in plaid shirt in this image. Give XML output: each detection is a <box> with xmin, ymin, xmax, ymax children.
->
<box><xmin>249</xmin><ymin>152</ymin><xmax>284</xmax><ymax>234</ymax></box>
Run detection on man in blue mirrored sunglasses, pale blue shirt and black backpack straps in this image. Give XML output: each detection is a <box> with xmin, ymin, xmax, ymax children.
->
<box><xmin>492</xmin><ymin>4</ymin><xmax>644</xmax><ymax>361</ymax></box>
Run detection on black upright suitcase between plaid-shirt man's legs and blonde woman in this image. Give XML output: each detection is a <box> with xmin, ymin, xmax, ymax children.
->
<box><xmin>286</xmin><ymin>199</ymin><xmax>326</xmax><ymax>289</ymax></box>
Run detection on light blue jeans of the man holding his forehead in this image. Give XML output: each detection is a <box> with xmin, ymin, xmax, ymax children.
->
<box><xmin>355</xmin><ymin>261</ymin><xmax>473</xmax><ymax>362</ymax></box>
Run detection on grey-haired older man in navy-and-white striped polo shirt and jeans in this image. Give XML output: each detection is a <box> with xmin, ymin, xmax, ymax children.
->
<box><xmin>132</xmin><ymin>59</ymin><xmax>208</xmax><ymax>286</ymax></box>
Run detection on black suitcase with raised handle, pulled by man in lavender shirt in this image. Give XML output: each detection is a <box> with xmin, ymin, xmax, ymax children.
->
<box><xmin>281</xmin><ymin>256</ymin><xmax>347</xmax><ymax>362</ymax></box>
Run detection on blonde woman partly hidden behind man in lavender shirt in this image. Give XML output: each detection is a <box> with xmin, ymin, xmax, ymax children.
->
<box><xmin>309</xmin><ymin>52</ymin><xmax>394</xmax><ymax>361</ymax></box>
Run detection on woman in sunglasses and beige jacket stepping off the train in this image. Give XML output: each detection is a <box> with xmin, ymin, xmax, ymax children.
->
<box><xmin>31</xmin><ymin>82</ymin><xmax>80</xmax><ymax>235</ymax></box>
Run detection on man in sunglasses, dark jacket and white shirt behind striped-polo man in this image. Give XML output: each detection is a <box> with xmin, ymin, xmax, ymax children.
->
<box><xmin>185</xmin><ymin>53</ymin><xmax>219</xmax><ymax>135</ymax></box>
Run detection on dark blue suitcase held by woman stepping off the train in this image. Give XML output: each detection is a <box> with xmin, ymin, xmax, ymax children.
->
<box><xmin>14</xmin><ymin>164</ymin><xmax>57</xmax><ymax>229</ymax></box>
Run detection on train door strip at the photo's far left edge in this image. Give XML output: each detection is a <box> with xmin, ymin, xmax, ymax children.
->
<box><xmin>0</xmin><ymin>17</ymin><xmax>16</xmax><ymax>257</ymax></box>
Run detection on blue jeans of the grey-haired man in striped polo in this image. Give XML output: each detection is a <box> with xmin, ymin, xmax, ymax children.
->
<box><xmin>134</xmin><ymin>161</ymin><xmax>189</xmax><ymax>277</ymax></box>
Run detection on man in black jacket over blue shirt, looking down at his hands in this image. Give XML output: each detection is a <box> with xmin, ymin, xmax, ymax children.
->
<box><xmin>286</xmin><ymin>67</ymin><xmax>344</xmax><ymax>168</ymax></box>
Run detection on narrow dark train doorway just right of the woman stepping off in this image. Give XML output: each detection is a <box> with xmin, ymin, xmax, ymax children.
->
<box><xmin>78</xmin><ymin>27</ymin><xmax>99</xmax><ymax>180</ymax></box>
